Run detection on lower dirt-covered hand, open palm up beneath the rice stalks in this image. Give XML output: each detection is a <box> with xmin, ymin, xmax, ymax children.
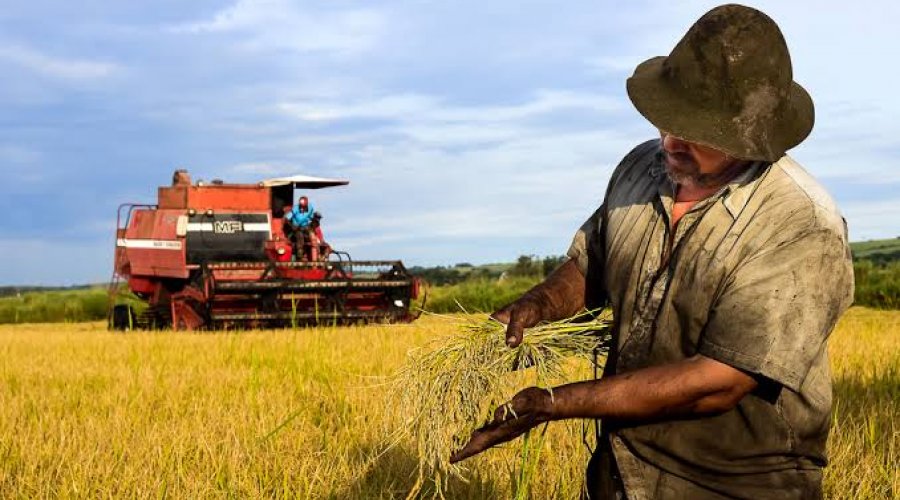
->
<box><xmin>450</xmin><ymin>387</ymin><xmax>553</xmax><ymax>463</ymax></box>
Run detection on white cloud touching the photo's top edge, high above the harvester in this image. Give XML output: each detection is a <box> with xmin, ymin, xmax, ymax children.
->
<box><xmin>172</xmin><ymin>0</ymin><xmax>385</xmax><ymax>53</ymax></box>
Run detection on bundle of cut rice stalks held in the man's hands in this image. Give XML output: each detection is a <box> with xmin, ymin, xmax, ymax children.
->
<box><xmin>389</xmin><ymin>312</ymin><xmax>610</xmax><ymax>497</ymax></box>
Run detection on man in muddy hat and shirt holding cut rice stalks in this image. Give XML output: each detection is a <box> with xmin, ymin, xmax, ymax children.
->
<box><xmin>452</xmin><ymin>5</ymin><xmax>853</xmax><ymax>499</ymax></box>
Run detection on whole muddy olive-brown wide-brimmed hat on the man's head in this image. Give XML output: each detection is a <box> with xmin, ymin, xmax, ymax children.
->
<box><xmin>627</xmin><ymin>4</ymin><xmax>815</xmax><ymax>161</ymax></box>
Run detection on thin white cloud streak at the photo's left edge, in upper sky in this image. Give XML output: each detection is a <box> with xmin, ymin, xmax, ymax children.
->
<box><xmin>0</xmin><ymin>44</ymin><xmax>120</xmax><ymax>81</ymax></box>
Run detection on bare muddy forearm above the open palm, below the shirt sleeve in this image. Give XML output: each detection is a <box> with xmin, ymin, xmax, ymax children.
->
<box><xmin>548</xmin><ymin>356</ymin><xmax>756</xmax><ymax>422</ymax></box>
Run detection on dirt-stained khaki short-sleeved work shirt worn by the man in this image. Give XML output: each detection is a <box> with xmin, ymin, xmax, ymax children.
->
<box><xmin>568</xmin><ymin>140</ymin><xmax>853</xmax><ymax>500</ymax></box>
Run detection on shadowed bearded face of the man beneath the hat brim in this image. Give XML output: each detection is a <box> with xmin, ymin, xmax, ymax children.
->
<box><xmin>659</xmin><ymin>130</ymin><xmax>744</xmax><ymax>188</ymax></box>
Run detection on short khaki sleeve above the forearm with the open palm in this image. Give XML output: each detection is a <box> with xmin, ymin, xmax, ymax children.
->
<box><xmin>699</xmin><ymin>229</ymin><xmax>853</xmax><ymax>392</ymax></box>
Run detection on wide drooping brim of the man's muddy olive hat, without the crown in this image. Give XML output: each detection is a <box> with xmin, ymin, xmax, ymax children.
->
<box><xmin>626</xmin><ymin>57</ymin><xmax>815</xmax><ymax>162</ymax></box>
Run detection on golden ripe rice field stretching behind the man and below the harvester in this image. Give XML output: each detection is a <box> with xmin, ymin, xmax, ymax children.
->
<box><xmin>0</xmin><ymin>308</ymin><xmax>900</xmax><ymax>499</ymax></box>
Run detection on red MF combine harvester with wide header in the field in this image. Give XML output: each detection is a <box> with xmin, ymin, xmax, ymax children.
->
<box><xmin>110</xmin><ymin>170</ymin><xmax>419</xmax><ymax>330</ymax></box>
